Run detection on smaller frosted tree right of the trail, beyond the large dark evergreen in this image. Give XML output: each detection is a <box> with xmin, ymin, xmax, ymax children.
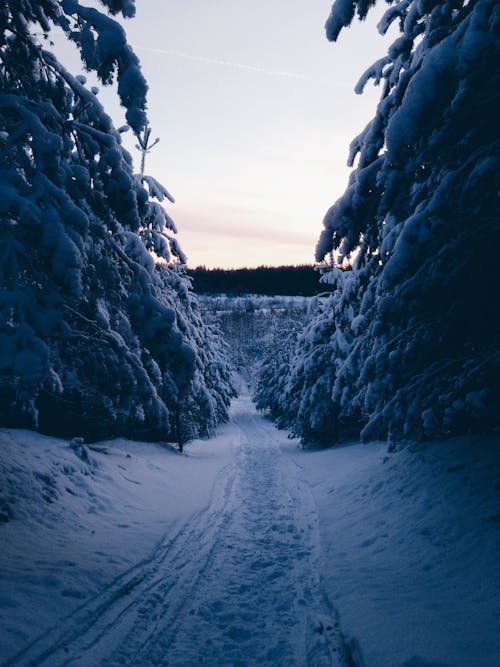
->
<box><xmin>256</xmin><ymin>284</ymin><xmax>359</xmax><ymax>446</ymax></box>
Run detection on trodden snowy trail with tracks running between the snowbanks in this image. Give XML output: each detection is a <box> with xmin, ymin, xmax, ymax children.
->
<box><xmin>6</xmin><ymin>396</ymin><xmax>350</xmax><ymax>667</ymax></box>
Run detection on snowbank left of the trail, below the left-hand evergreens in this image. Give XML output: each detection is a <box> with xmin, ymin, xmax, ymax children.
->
<box><xmin>0</xmin><ymin>426</ymin><xmax>234</xmax><ymax>664</ymax></box>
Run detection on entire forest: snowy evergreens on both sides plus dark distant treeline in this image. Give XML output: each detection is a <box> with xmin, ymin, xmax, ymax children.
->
<box><xmin>0</xmin><ymin>0</ymin><xmax>500</xmax><ymax>444</ymax></box>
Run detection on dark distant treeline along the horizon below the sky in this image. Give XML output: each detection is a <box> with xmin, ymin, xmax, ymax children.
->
<box><xmin>188</xmin><ymin>264</ymin><xmax>329</xmax><ymax>296</ymax></box>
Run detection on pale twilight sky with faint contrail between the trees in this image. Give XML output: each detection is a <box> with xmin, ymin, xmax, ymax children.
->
<box><xmin>58</xmin><ymin>0</ymin><xmax>392</xmax><ymax>268</ymax></box>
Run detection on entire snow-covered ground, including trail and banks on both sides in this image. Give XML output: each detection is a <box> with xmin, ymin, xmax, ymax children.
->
<box><xmin>0</xmin><ymin>396</ymin><xmax>500</xmax><ymax>667</ymax></box>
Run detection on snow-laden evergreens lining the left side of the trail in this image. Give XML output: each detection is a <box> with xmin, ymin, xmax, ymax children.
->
<box><xmin>0</xmin><ymin>0</ymin><xmax>232</xmax><ymax>446</ymax></box>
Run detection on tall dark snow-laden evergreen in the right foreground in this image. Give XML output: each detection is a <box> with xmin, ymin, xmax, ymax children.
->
<box><xmin>256</xmin><ymin>0</ymin><xmax>500</xmax><ymax>446</ymax></box>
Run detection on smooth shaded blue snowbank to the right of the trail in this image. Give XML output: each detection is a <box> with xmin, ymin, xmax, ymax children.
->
<box><xmin>287</xmin><ymin>438</ymin><xmax>500</xmax><ymax>667</ymax></box>
